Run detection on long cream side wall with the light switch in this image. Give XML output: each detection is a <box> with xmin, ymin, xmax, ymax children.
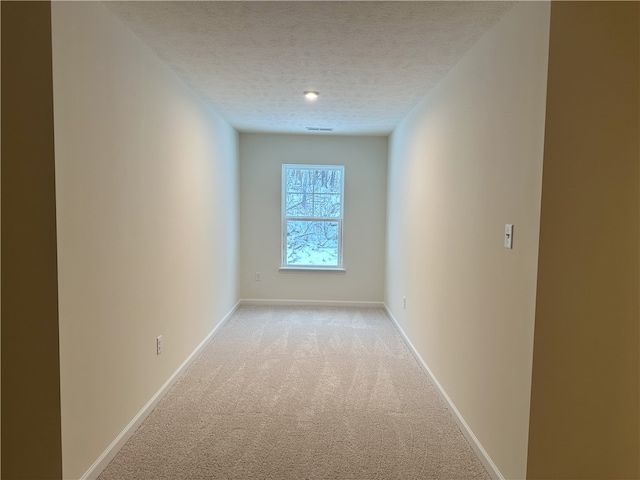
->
<box><xmin>385</xmin><ymin>2</ymin><xmax>549</xmax><ymax>478</ymax></box>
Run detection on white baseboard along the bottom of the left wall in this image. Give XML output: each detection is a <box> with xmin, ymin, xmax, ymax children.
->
<box><xmin>80</xmin><ymin>301</ymin><xmax>240</xmax><ymax>480</ymax></box>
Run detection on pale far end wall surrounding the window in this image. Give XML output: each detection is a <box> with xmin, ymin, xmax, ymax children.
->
<box><xmin>240</xmin><ymin>133</ymin><xmax>388</xmax><ymax>302</ymax></box>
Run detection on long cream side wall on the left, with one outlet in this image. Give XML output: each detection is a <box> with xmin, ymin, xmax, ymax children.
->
<box><xmin>52</xmin><ymin>2</ymin><xmax>238</xmax><ymax>478</ymax></box>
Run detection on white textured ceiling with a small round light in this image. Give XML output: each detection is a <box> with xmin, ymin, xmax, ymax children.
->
<box><xmin>106</xmin><ymin>1</ymin><xmax>513</xmax><ymax>135</ymax></box>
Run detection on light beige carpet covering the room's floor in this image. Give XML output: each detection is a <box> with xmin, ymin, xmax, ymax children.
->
<box><xmin>99</xmin><ymin>306</ymin><xmax>490</xmax><ymax>480</ymax></box>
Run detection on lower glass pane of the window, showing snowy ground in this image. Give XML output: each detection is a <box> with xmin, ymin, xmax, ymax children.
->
<box><xmin>287</xmin><ymin>221</ymin><xmax>338</xmax><ymax>267</ymax></box>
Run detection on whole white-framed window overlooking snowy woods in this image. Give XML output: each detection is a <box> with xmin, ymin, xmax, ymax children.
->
<box><xmin>282</xmin><ymin>165</ymin><xmax>344</xmax><ymax>269</ymax></box>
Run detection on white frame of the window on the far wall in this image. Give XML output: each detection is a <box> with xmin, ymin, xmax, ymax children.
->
<box><xmin>280</xmin><ymin>163</ymin><xmax>345</xmax><ymax>272</ymax></box>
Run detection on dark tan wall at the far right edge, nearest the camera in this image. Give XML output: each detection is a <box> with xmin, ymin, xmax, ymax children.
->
<box><xmin>527</xmin><ymin>2</ymin><xmax>640</xmax><ymax>479</ymax></box>
